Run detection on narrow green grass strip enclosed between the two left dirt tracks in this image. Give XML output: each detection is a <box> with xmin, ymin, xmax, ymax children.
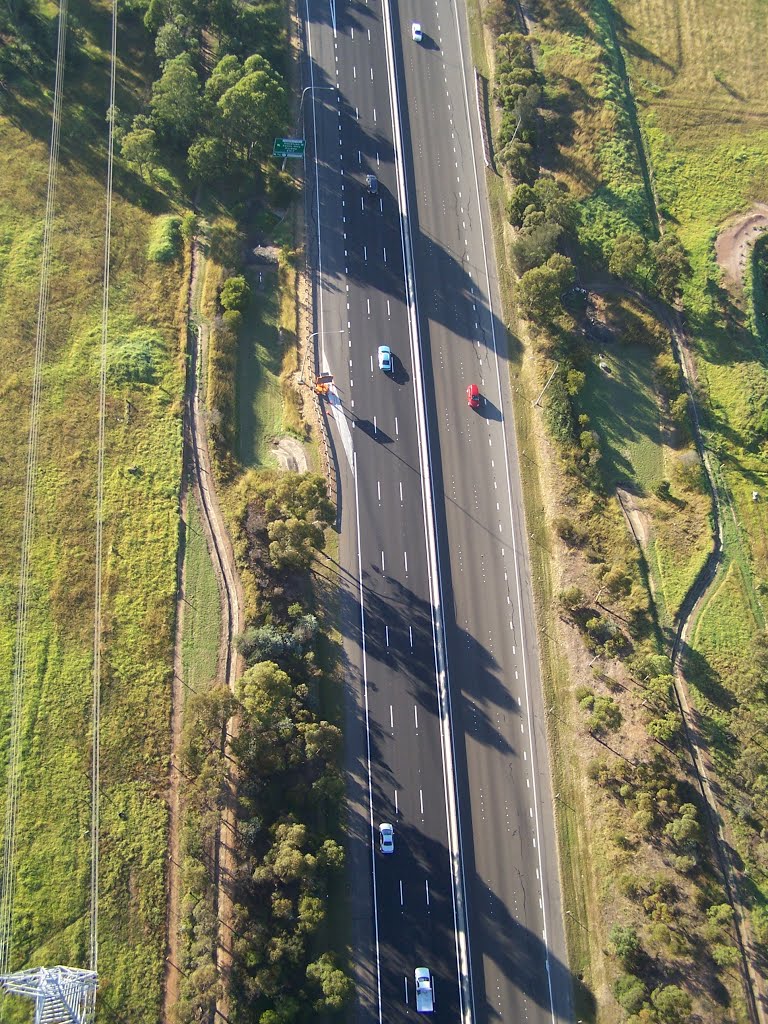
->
<box><xmin>182</xmin><ymin>495</ymin><xmax>221</xmax><ymax>692</ymax></box>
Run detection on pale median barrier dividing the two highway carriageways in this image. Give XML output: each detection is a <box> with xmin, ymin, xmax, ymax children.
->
<box><xmin>382</xmin><ymin>0</ymin><xmax>475</xmax><ymax>1024</ymax></box>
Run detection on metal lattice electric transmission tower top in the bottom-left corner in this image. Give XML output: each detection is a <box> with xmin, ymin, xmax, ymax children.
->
<box><xmin>0</xmin><ymin>967</ymin><xmax>97</xmax><ymax>1024</ymax></box>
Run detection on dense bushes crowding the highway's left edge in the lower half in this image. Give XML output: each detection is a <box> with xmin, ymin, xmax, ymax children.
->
<box><xmin>180</xmin><ymin>471</ymin><xmax>351</xmax><ymax>1024</ymax></box>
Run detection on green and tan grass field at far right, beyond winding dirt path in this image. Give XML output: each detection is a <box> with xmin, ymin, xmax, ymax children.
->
<box><xmin>616</xmin><ymin>0</ymin><xmax>768</xmax><ymax>898</ymax></box>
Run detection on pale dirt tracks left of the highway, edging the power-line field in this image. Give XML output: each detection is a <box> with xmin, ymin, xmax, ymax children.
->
<box><xmin>163</xmin><ymin>238</ymin><xmax>244</xmax><ymax>1024</ymax></box>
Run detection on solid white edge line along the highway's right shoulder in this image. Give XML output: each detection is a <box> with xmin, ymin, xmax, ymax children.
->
<box><xmin>454</xmin><ymin>4</ymin><xmax>559</xmax><ymax>1011</ymax></box>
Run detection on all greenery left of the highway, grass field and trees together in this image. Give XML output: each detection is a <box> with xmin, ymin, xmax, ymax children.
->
<box><xmin>0</xmin><ymin>0</ymin><xmax>350</xmax><ymax>1024</ymax></box>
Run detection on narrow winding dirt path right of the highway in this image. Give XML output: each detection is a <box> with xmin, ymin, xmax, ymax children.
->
<box><xmin>586</xmin><ymin>276</ymin><xmax>768</xmax><ymax>1024</ymax></box>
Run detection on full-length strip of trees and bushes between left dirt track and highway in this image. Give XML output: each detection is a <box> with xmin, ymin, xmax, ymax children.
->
<box><xmin>143</xmin><ymin>0</ymin><xmax>351</xmax><ymax>1024</ymax></box>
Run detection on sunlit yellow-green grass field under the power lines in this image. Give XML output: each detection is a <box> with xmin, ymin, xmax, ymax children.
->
<box><xmin>0</xmin><ymin>3</ymin><xmax>183</xmax><ymax>1020</ymax></box>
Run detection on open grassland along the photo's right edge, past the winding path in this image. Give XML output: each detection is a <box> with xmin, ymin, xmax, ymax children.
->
<box><xmin>617</xmin><ymin>0</ymin><xmax>768</xmax><ymax>950</ymax></box>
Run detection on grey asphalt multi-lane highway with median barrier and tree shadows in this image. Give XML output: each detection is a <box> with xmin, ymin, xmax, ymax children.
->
<box><xmin>299</xmin><ymin>0</ymin><xmax>572</xmax><ymax>1022</ymax></box>
